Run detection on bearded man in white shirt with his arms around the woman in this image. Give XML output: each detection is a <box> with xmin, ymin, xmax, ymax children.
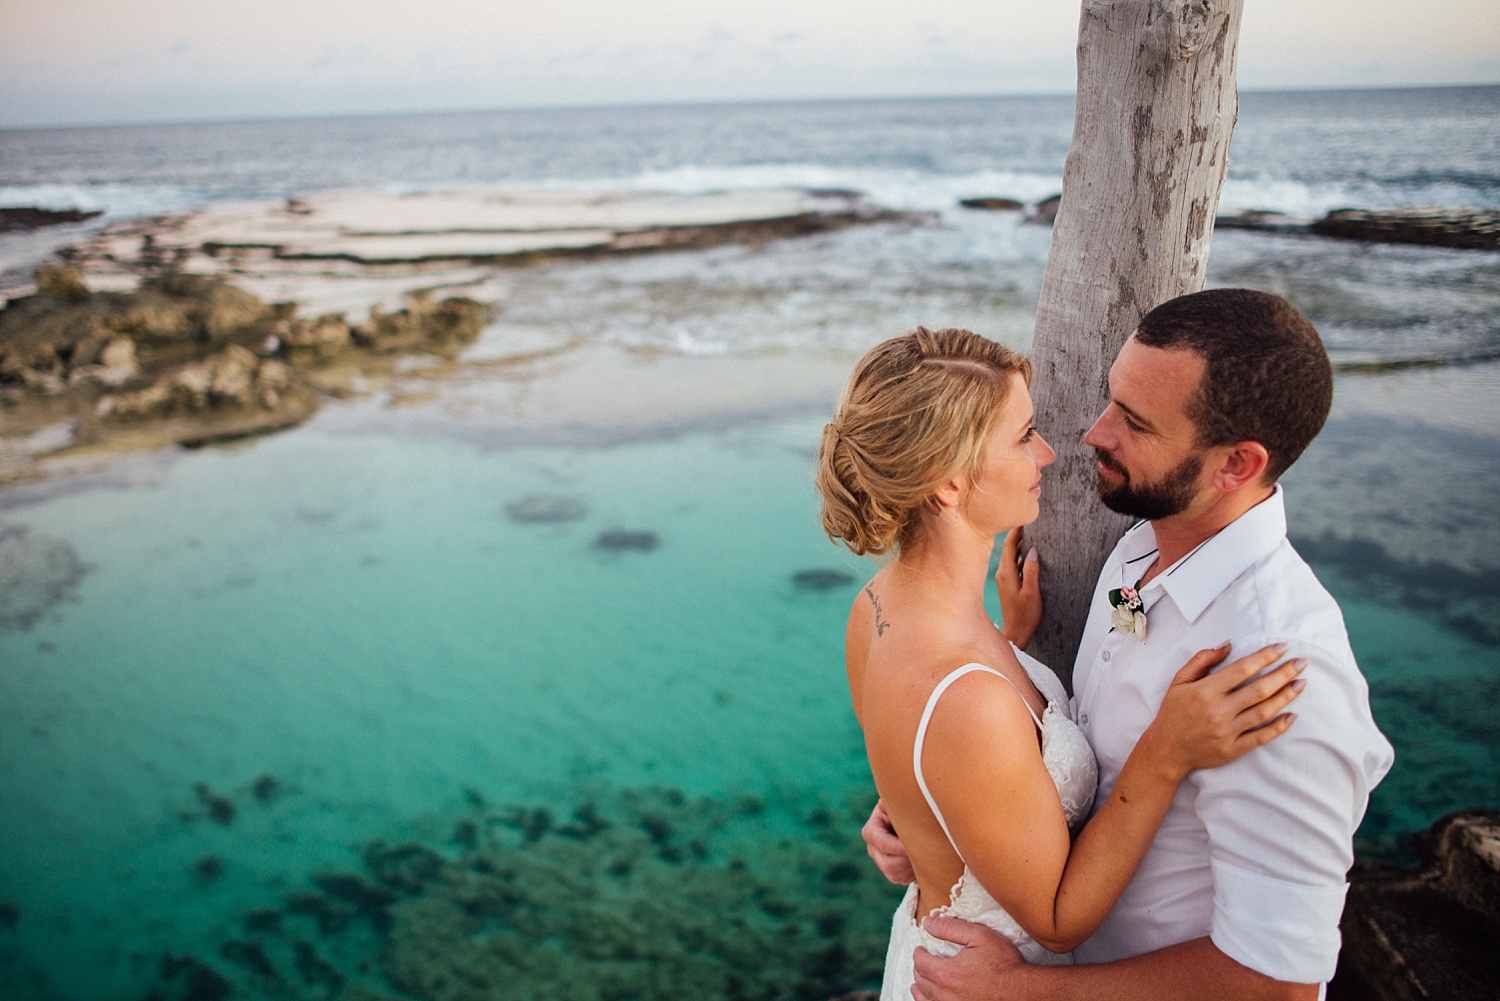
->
<box><xmin>866</xmin><ymin>288</ymin><xmax>1392</xmax><ymax>1001</ymax></box>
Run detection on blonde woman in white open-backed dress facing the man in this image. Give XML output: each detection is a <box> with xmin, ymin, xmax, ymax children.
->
<box><xmin>818</xmin><ymin>327</ymin><xmax>1304</xmax><ymax>1001</ymax></box>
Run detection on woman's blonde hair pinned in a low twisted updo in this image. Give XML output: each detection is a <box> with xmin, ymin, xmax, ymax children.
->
<box><xmin>818</xmin><ymin>327</ymin><xmax>1032</xmax><ymax>555</ymax></box>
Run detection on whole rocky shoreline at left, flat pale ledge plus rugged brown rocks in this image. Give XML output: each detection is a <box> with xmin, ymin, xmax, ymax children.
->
<box><xmin>0</xmin><ymin>189</ymin><xmax>905</xmax><ymax>485</ymax></box>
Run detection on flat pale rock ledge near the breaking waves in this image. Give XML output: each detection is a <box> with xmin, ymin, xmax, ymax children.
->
<box><xmin>52</xmin><ymin>189</ymin><xmax>900</xmax><ymax>283</ymax></box>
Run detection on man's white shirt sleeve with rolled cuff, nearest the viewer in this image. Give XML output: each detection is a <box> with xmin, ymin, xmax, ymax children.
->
<box><xmin>1188</xmin><ymin>644</ymin><xmax>1392</xmax><ymax>983</ymax></box>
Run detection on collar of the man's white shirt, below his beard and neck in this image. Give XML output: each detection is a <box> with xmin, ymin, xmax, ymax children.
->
<box><xmin>1121</xmin><ymin>483</ymin><xmax>1287</xmax><ymax>623</ymax></box>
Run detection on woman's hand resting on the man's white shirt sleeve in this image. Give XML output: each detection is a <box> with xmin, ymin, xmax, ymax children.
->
<box><xmin>1142</xmin><ymin>644</ymin><xmax>1308</xmax><ymax>780</ymax></box>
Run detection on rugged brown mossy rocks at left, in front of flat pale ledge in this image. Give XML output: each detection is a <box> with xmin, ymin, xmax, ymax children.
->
<box><xmin>0</xmin><ymin>267</ymin><xmax>489</xmax><ymax>479</ymax></box>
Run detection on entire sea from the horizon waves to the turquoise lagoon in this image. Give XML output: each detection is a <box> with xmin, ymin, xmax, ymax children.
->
<box><xmin>0</xmin><ymin>87</ymin><xmax>1500</xmax><ymax>1001</ymax></box>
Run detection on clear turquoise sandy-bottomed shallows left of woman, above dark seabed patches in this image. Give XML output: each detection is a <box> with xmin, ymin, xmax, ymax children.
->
<box><xmin>0</xmin><ymin>402</ymin><xmax>900</xmax><ymax>996</ymax></box>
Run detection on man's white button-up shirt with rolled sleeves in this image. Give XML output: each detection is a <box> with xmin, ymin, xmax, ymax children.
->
<box><xmin>1073</xmin><ymin>486</ymin><xmax>1394</xmax><ymax>983</ymax></box>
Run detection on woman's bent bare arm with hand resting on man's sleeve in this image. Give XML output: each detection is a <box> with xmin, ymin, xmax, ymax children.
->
<box><xmin>923</xmin><ymin>645</ymin><xmax>1302</xmax><ymax>951</ymax></box>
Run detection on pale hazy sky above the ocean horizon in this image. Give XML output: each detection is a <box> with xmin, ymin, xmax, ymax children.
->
<box><xmin>0</xmin><ymin>0</ymin><xmax>1500</xmax><ymax>128</ymax></box>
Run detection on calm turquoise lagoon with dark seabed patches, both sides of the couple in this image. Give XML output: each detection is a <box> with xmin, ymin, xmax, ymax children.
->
<box><xmin>0</xmin><ymin>355</ymin><xmax>1500</xmax><ymax>998</ymax></box>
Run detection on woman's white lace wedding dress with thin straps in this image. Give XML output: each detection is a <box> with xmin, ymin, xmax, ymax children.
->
<box><xmin>881</xmin><ymin>647</ymin><xmax>1100</xmax><ymax>1001</ymax></box>
